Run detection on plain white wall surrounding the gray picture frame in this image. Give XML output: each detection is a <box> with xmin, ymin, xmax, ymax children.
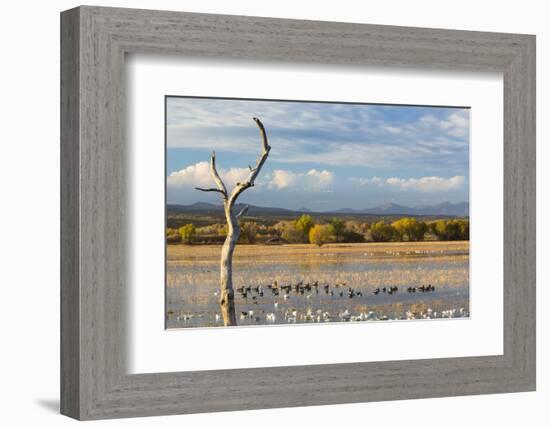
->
<box><xmin>0</xmin><ymin>0</ymin><xmax>550</xmax><ymax>426</ymax></box>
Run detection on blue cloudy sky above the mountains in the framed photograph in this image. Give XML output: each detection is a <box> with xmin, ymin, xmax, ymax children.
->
<box><xmin>166</xmin><ymin>97</ymin><xmax>469</xmax><ymax>211</ymax></box>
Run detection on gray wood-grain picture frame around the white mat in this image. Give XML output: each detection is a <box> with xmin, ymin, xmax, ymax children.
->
<box><xmin>61</xmin><ymin>6</ymin><xmax>536</xmax><ymax>420</ymax></box>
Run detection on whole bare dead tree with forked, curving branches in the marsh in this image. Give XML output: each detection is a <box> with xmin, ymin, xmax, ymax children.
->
<box><xmin>196</xmin><ymin>117</ymin><xmax>271</xmax><ymax>326</ymax></box>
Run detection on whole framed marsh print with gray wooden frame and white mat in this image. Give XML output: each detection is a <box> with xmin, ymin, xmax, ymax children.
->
<box><xmin>61</xmin><ymin>6</ymin><xmax>535</xmax><ymax>419</ymax></box>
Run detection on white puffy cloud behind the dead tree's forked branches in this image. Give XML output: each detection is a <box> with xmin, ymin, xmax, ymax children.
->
<box><xmin>166</xmin><ymin>162</ymin><xmax>249</xmax><ymax>187</ymax></box>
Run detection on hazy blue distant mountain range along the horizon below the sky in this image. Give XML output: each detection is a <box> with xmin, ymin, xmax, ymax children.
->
<box><xmin>167</xmin><ymin>202</ymin><xmax>470</xmax><ymax>217</ymax></box>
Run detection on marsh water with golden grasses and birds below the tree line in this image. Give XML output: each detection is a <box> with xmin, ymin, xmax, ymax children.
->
<box><xmin>165</xmin><ymin>242</ymin><xmax>470</xmax><ymax>328</ymax></box>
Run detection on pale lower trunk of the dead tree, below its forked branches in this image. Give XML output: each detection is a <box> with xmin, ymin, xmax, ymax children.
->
<box><xmin>220</xmin><ymin>201</ymin><xmax>240</xmax><ymax>326</ymax></box>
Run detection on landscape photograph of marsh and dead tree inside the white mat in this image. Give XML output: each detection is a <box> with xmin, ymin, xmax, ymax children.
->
<box><xmin>165</xmin><ymin>96</ymin><xmax>470</xmax><ymax>329</ymax></box>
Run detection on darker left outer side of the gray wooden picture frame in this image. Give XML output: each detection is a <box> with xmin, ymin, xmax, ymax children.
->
<box><xmin>60</xmin><ymin>10</ymin><xmax>80</xmax><ymax>417</ymax></box>
